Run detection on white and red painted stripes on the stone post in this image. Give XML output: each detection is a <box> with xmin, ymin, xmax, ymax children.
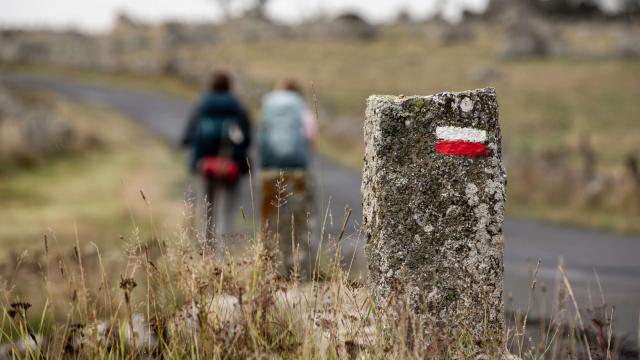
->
<box><xmin>436</xmin><ymin>126</ymin><xmax>489</xmax><ymax>157</ymax></box>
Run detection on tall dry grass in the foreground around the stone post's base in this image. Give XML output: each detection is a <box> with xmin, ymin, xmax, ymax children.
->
<box><xmin>0</xmin><ymin>195</ymin><xmax>637</xmax><ymax>359</ymax></box>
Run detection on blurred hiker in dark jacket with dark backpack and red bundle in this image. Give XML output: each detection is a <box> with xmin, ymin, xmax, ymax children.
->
<box><xmin>183</xmin><ymin>71</ymin><xmax>251</xmax><ymax>245</ymax></box>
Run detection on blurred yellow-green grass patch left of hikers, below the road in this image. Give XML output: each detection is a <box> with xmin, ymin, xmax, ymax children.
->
<box><xmin>0</xmin><ymin>93</ymin><xmax>186</xmax><ymax>258</ymax></box>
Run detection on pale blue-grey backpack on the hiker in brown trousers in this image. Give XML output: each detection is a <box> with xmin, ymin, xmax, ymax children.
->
<box><xmin>260</xmin><ymin>91</ymin><xmax>309</xmax><ymax>168</ymax></box>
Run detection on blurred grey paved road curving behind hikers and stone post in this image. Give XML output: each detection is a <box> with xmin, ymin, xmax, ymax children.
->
<box><xmin>1</xmin><ymin>75</ymin><xmax>640</xmax><ymax>338</ymax></box>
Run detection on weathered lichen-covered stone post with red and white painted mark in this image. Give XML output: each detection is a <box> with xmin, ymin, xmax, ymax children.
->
<box><xmin>362</xmin><ymin>88</ymin><xmax>506</xmax><ymax>345</ymax></box>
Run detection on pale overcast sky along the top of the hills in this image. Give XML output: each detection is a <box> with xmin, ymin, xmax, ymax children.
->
<box><xmin>0</xmin><ymin>0</ymin><xmax>488</xmax><ymax>32</ymax></box>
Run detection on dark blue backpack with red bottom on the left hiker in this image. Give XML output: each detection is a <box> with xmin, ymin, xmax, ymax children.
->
<box><xmin>195</xmin><ymin>117</ymin><xmax>244</xmax><ymax>181</ymax></box>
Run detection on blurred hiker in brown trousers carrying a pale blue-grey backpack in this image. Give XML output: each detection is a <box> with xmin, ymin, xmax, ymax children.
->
<box><xmin>259</xmin><ymin>80</ymin><xmax>316</xmax><ymax>276</ymax></box>
